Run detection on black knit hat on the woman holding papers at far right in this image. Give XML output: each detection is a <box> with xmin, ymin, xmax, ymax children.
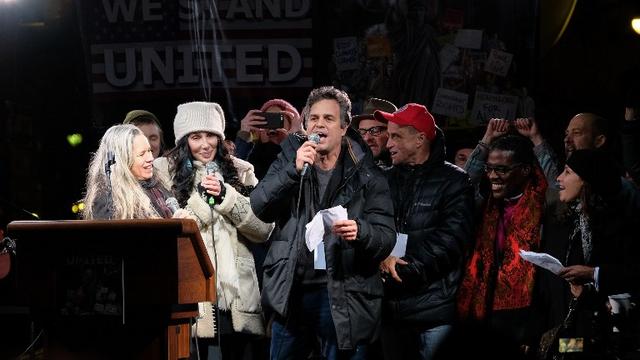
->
<box><xmin>567</xmin><ymin>149</ymin><xmax>622</xmax><ymax>197</ymax></box>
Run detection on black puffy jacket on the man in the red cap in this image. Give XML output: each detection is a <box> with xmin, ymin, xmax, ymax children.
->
<box><xmin>384</xmin><ymin>129</ymin><xmax>474</xmax><ymax>328</ymax></box>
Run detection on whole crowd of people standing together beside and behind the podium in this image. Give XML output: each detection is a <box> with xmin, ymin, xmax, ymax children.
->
<box><xmin>83</xmin><ymin>87</ymin><xmax>640</xmax><ymax>359</ymax></box>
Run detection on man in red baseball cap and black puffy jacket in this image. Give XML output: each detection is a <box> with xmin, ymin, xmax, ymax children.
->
<box><xmin>374</xmin><ymin>104</ymin><xmax>474</xmax><ymax>359</ymax></box>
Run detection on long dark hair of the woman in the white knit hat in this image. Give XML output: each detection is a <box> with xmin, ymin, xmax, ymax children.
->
<box><xmin>166</xmin><ymin>134</ymin><xmax>253</xmax><ymax>207</ymax></box>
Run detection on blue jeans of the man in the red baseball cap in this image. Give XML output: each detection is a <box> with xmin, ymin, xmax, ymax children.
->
<box><xmin>382</xmin><ymin>324</ymin><xmax>453</xmax><ymax>360</ymax></box>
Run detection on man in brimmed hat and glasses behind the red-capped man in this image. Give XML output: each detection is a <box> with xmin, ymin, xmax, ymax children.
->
<box><xmin>351</xmin><ymin>98</ymin><xmax>398</xmax><ymax>170</ymax></box>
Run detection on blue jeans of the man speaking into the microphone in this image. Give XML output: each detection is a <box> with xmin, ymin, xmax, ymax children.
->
<box><xmin>271</xmin><ymin>287</ymin><xmax>367</xmax><ymax>360</ymax></box>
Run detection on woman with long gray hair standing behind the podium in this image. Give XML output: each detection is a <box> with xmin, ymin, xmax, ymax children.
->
<box><xmin>82</xmin><ymin>125</ymin><xmax>189</xmax><ymax>220</ymax></box>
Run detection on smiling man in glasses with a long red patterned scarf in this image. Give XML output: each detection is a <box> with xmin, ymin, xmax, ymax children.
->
<box><xmin>458</xmin><ymin>134</ymin><xmax>547</xmax><ymax>358</ymax></box>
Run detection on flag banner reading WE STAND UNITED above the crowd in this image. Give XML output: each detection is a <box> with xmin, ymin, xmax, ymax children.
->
<box><xmin>76</xmin><ymin>0</ymin><xmax>312</xmax><ymax>96</ymax></box>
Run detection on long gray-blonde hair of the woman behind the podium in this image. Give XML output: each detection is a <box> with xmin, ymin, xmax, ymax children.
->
<box><xmin>82</xmin><ymin>125</ymin><xmax>160</xmax><ymax>219</ymax></box>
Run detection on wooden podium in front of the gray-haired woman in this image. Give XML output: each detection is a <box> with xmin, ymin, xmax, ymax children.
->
<box><xmin>8</xmin><ymin>219</ymin><xmax>216</xmax><ymax>359</ymax></box>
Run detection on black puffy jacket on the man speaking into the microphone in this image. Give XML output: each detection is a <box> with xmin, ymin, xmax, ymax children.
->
<box><xmin>251</xmin><ymin>128</ymin><xmax>395</xmax><ymax>349</ymax></box>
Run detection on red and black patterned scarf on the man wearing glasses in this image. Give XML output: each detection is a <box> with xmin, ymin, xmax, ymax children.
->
<box><xmin>458</xmin><ymin>166</ymin><xmax>547</xmax><ymax>320</ymax></box>
